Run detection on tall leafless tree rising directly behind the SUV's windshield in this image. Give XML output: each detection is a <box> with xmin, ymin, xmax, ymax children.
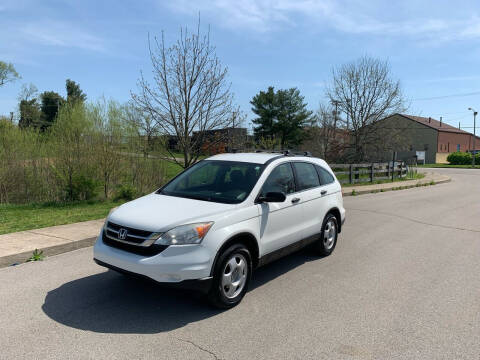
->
<box><xmin>132</xmin><ymin>21</ymin><xmax>232</xmax><ymax>168</ymax></box>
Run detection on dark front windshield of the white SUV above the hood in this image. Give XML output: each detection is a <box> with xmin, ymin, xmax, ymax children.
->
<box><xmin>158</xmin><ymin>160</ymin><xmax>265</xmax><ymax>204</ymax></box>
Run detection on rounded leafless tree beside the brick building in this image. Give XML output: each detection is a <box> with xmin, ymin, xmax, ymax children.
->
<box><xmin>327</xmin><ymin>57</ymin><xmax>405</xmax><ymax>161</ymax></box>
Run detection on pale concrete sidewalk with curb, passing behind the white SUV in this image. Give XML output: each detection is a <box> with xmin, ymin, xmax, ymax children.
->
<box><xmin>0</xmin><ymin>172</ymin><xmax>450</xmax><ymax>268</ymax></box>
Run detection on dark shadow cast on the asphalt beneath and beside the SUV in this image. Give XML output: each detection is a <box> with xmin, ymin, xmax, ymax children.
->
<box><xmin>42</xmin><ymin>250</ymin><xmax>319</xmax><ymax>334</ymax></box>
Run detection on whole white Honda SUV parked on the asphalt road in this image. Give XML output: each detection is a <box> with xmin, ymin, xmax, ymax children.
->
<box><xmin>94</xmin><ymin>152</ymin><xmax>345</xmax><ymax>308</ymax></box>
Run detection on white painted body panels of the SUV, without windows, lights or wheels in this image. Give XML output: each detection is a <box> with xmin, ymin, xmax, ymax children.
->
<box><xmin>94</xmin><ymin>153</ymin><xmax>345</xmax><ymax>283</ymax></box>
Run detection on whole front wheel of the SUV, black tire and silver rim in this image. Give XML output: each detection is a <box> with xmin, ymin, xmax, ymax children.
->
<box><xmin>208</xmin><ymin>244</ymin><xmax>252</xmax><ymax>309</ymax></box>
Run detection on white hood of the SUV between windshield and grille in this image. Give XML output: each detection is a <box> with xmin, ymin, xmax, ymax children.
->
<box><xmin>108</xmin><ymin>193</ymin><xmax>237</xmax><ymax>232</ymax></box>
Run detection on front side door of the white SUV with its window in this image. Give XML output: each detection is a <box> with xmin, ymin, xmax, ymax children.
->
<box><xmin>257</xmin><ymin>162</ymin><xmax>302</xmax><ymax>254</ymax></box>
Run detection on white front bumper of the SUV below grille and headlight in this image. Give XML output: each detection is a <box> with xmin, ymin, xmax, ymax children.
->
<box><xmin>93</xmin><ymin>236</ymin><xmax>213</xmax><ymax>284</ymax></box>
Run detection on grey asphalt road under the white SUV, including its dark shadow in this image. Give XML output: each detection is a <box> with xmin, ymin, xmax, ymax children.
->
<box><xmin>0</xmin><ymin>169</ymin><xmax>480</xmax><ymax>359</ymax></box>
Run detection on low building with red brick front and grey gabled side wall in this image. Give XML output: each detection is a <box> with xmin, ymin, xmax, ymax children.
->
<box><xmin>382</xmin><ymin>114</ymin><xmax>480</xmax><ymax>164</ymax></box>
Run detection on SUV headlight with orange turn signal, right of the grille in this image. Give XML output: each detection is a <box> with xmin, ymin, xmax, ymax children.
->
<box><xmin>155</xmin><ymin>222</ymin><xmax>213</xmax><ymax>245</ymax></box>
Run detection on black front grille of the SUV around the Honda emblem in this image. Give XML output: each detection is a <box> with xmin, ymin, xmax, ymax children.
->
<box><xmin>102</xmin><ymin>221</ymin><xmax>168</xmax><ymax>256</ymax></box>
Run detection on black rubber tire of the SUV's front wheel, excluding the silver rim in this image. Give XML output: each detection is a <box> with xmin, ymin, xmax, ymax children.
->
<box><xmin>209</xmin><ymin>244</ymin><xmax>252</xmax><ymax>309</ymax></box>
